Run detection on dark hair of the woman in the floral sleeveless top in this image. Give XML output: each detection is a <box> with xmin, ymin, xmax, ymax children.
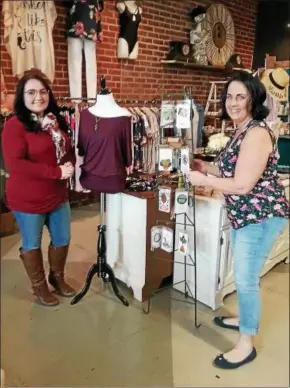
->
<box><xmin>221</xmin><ymin>70</ymin><xmax>269</xmax><ymax>120</ymax></box>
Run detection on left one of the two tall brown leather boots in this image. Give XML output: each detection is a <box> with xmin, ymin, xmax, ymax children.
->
<box><xmin>20</xmin><ymin>248</ymin><xmax>59</xmax><ymax>306</ymax></box>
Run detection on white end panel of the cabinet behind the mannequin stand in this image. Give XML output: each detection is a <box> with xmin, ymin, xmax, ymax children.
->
<box><xmin>106</xmin><ymin>193</ymin><xmax>146</xmax><ymax>301</ymax></box>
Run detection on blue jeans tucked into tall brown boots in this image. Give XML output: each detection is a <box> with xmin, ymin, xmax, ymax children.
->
<box><xmin>13</xmin><ymin>202</ymin><xmax>71</xmax><ymax>251</ymax></box>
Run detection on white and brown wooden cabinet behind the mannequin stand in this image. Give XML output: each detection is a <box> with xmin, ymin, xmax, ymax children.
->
<box><xmin>106</xmin><ymin>192</ymin><xmax>173</xmax><ymax>302</ymax></box>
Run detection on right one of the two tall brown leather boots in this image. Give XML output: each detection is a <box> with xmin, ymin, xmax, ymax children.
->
<box><xmin>48</xmin><ymin>245</ymin><xmax>76</xmax><ymax>297</ymax></box>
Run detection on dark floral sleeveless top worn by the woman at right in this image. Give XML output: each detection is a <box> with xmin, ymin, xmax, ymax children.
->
<box><xmin>218</xmin><ymin>120</ymin><xmax>289</xmax><ymax>229</ymax></box>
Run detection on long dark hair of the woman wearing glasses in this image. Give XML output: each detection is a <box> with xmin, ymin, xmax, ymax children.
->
<box><xmin>14</xmin><ymin>70</ymin><xmax>70</xmax><ymax>133</ymax></box>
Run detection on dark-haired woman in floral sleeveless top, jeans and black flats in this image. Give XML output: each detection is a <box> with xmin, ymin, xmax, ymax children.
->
<box><xmin>189</xmin><ymin>71</ymin><xmax>289</xmax><ymax>369</ymax></box>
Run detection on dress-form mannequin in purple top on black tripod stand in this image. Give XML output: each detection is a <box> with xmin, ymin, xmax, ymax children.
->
<box><xmin>71</xmin><ymin>77</ymin><xmax>132</xmax><ymax>306</ymax></box>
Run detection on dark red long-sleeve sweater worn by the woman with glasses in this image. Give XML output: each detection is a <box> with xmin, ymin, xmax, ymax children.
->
<box><xmin>2</xmin><ymin>116</ymin><xmax>75</xmax><ymax>214</ymax></box>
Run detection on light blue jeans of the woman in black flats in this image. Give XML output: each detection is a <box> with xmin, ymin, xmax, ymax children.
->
<box><xmin>231</xmin><ymin>217</ymin><xmax>288</xmax><ymax>336</ymax></box>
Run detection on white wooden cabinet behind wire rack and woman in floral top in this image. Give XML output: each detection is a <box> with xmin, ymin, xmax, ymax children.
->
<box><xmin>173</xmin><ymin>183</ymin><xmax>289</xmax><ymax>310</ymax></box>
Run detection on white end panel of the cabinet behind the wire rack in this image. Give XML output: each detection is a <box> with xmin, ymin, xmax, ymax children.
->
<box><xmin>173</xmin><ymin>196</ymin><xmax>228</xmax><ymax>309</ymax></box>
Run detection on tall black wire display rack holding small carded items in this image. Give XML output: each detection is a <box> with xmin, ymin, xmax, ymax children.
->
<box><xmin>142</xmin><ymin>87</ymin><xmax>200</xmax><ymax>328</ymax></box>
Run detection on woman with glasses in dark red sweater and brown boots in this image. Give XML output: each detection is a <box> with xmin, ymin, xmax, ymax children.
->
<box><xmin>2</xmin><ymin>71</ymin><xmax>75</xmax><ymax>306</ymax></box>
